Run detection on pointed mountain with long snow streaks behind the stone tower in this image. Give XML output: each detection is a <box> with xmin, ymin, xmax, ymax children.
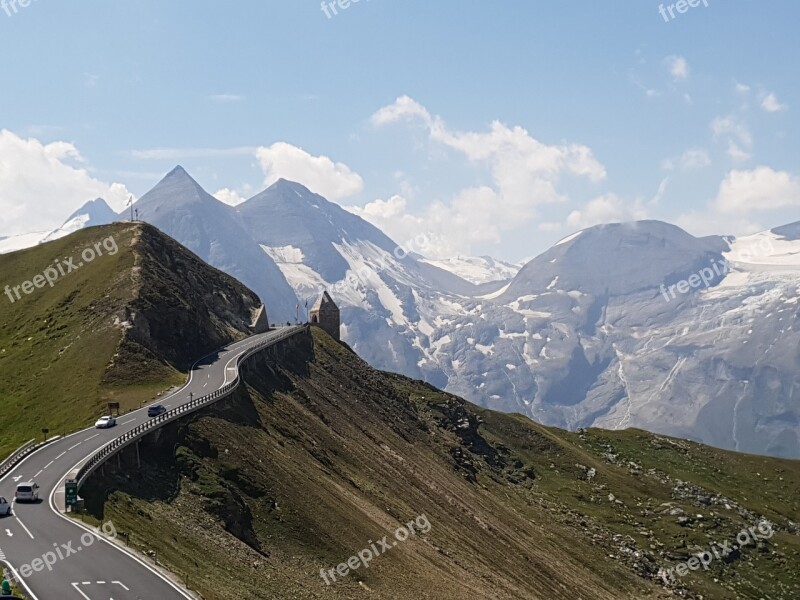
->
<box><xmin>236</xmin><ymin>180</ymin><xmax>478</xmax><ymax>385</ymax></box>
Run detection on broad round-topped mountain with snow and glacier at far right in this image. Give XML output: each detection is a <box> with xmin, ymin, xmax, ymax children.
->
<box><xmin>433</xmin><ymin>221</ymin><xmax>800</xmax><ymax>457</ymax></box>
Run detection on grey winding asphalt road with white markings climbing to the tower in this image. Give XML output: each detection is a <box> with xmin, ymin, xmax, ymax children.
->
<box><xmin>0</xmin><ymin>328</ymin><xmax>302</xmax><ymax>600</ymax></box>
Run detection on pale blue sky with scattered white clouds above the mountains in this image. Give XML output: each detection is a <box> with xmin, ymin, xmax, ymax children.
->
<box><xmin>0</xmin><ymin>0</ymin><xmax>800</xmax><ymax>260</ymax></box>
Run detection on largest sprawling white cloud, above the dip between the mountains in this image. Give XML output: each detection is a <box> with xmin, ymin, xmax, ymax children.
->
<box><xmin>365</xmin><ymin>96</ymin><xmax>606</xmax><ymax>256</ymax></box>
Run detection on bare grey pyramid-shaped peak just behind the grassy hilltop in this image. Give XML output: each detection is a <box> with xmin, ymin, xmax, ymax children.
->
<box><xmin>131</xmin><ymin>166</ymin><xmax>297</xmax><ymax>321</ymax></box>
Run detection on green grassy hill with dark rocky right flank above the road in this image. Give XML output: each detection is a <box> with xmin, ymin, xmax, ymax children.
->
<box><xmin>0</xmin><ymin>224</ymin><xmax>266</xmax><ymax>459</ymax></box>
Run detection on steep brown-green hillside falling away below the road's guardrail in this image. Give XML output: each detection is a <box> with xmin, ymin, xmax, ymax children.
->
<box><xmin>86</xmin><ymin>331</ymin><xmax>800</xmax><ymax>600</ymax></box>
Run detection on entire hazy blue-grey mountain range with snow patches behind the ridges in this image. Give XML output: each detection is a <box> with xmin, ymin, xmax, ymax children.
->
<box><xmin>9</xmin><ymin>168</ymin><xmax>800</xmax><ymax>458</ymax></box>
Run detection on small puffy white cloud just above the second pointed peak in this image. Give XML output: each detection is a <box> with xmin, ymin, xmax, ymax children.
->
<box><xmin>256</xmin><ymin>142</ymin><xmax>364</xmax><ymax>200</ymax></box>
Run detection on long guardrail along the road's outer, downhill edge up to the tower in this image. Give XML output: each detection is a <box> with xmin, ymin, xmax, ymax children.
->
<box><xmin>75</xmin><ymin>325</ymin><xmax>309</xmax><ymax>488</ymax></box>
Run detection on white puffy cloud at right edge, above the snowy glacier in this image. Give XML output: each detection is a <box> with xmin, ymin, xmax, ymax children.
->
<box><xmin>714</xmin><ymin>167</ymin><xmax>800</xmax><ymax>215</ymax></box>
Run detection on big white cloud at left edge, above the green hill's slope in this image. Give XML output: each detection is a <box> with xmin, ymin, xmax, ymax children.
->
<box><xmin>0</xmin><ymin>129</ymin><xmax>129</xmax><ymax>235</ymax></box>
